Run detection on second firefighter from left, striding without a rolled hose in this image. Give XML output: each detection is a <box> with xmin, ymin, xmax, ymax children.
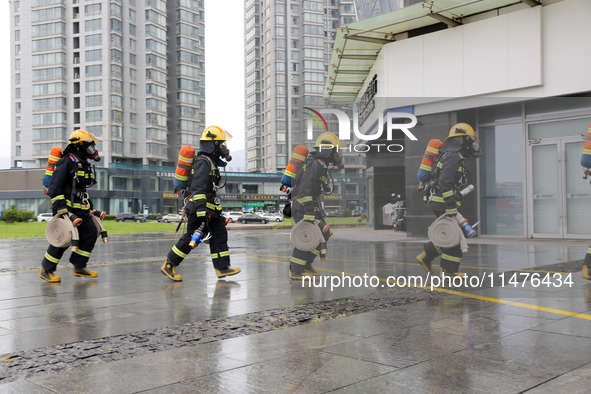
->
<box><xmin>160</xmin><ymin>126</ymin><xmax>240</xmax><ymax>282</ymax></box>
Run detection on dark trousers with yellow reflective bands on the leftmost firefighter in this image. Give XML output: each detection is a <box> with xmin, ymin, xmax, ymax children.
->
<box><xmin>41</xmin><ymin>214</ymin><xmax>98</xmax><ymax>272</ymax></box>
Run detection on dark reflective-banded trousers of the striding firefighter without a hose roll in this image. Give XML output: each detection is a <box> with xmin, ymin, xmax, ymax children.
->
<box><xmin>167</xmin><ymin>211</ymin><xmax>230</xmax><ymax>269</ymax></box>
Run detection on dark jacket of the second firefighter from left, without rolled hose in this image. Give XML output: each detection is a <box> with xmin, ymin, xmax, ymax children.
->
<box><xmin>189</xmin><ymin>154</ymin><xmax>222</xmax><ymax>218</ymax></box>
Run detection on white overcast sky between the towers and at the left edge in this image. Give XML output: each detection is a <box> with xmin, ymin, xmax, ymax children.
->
<box><xmin>0</xmin><ymin>0</ymin><xmax>244</xmax><ymax>169</ymax></box>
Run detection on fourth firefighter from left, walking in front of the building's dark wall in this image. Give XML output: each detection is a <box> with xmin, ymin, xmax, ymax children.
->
<box><xmin>417</xmin><ymin>123</ymin><xmax>481</xmax><ymax>276</ymax></box>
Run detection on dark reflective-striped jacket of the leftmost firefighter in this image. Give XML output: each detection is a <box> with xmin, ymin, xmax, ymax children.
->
<box><xmin>48</xmin><ymin>154</ymin><xmax>96</xmax><ymax>215</ymax></box>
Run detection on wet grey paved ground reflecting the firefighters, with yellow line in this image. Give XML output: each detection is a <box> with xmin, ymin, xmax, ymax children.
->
<box><xmin>0</xmin><ymin>229</ymin><xmax>591</xmax><ymax>393</ymax></box>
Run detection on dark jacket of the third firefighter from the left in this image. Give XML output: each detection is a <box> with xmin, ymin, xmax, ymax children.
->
<box><xmin>292</xmin><ymin>155</ymin><xmax>328</xmax><ymax>221</ymax></box>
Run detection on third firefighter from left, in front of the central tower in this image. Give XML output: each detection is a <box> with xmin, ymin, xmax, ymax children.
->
<box><xmin>289</xmin><ymin>132</ymin><xmax>343</xmax><ymax>280</ymax></box>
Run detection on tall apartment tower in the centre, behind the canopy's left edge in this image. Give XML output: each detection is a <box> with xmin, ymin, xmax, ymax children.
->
<box><xmin>245</xmin><ymin>0</ymin><xmax>363</xmax><ymax>172</ymax></box>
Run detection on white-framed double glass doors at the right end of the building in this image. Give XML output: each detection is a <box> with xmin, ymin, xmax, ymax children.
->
<box><xmin>528</xmin><ymin>137</ymin><xmax>591</xmax><ymax>238</ymax></box>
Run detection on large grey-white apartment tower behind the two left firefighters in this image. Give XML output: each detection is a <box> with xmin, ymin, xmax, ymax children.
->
<box><xmin>10</xmin><ymin>0</ymin><xmax>205</xmax><ymax>168</ymax></box>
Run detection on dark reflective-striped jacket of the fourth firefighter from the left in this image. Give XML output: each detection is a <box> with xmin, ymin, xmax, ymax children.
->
<box><xmin>429</xmin><ymin>151</ymin><xmax>466</xmax><ymax>215</ymax></box>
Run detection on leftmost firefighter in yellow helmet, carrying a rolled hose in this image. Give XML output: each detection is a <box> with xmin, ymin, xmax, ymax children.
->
<box><xmin>39</xmin><ymin>129</ymin><xmax>100</xmax><ymax>283</ymax></box>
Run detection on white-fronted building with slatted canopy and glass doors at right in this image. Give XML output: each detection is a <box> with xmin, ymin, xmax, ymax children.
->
<box><xmin>325</xmin><ymin>0</ymin><xmax>591</xmax><ymax>238</ymax></box>
